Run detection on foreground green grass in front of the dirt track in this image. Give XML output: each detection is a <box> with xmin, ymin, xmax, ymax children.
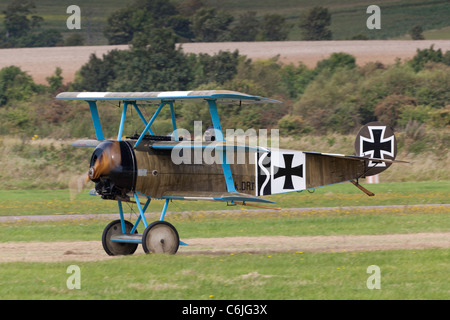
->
<box><xmin>0</xmin><ymin>249</ymin><xmax>450</xmax><ymax>300</ymax></box>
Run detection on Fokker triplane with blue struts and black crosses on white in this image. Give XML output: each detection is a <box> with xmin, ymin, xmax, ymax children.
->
<box><xmin>57</xmin><ymin>90</ymin><xmax>404</xmax><ymax>255</ymax></box>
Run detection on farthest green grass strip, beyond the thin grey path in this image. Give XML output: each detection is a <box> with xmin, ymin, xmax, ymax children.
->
<box><xmin>0</xmin><ymin>180</ymin><xmax>450</xmax><ymax>216</ymax></box>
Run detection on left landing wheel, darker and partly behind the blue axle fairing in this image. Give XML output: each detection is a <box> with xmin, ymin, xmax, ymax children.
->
<box><xmin>102</xmin><ymin>220</ymin><xmax>138</xmax><ymax>256</ymax></box>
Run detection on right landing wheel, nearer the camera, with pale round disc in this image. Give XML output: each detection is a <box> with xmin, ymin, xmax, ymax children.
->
<box><xmin>142</xmin><ymin>221</ymin><xmax>180</xmax><ymax>254</ymax></box>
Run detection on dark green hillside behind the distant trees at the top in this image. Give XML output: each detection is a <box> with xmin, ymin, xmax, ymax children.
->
<box><xmin>0</xmin><ymin>0</ymin><xmax>450</xmax><ymax>45</ymax></box>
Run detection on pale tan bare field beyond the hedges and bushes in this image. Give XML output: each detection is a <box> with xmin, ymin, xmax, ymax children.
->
<box><xmin>0</xmin><ymin>40</ymin><xmax>450</xmax><ymax>84</ymax></box>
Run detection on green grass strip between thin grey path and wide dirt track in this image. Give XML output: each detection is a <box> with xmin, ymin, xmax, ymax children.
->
<box><xmin>0</xmin><ymin>198</ymin><xmax>450</xmax><ymax>243</ymax></box>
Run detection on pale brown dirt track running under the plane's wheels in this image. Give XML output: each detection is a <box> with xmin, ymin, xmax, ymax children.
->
<box><xmin>0</xmin><ymin>232</ymin><xmax>450</xmax><ymax>263</ymax></box>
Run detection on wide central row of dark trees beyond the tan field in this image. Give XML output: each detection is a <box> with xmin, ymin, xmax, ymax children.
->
<box><xmin>104</xmin><ymin>0</ymin><xmax>332</xmax><ymax>44</ymax></box>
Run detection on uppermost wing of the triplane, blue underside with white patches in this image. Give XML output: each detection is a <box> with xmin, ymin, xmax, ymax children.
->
<box><xmin>56</xmin><ymin>90</ymin><xmax>282</xmax><ymax>104</ymax></box>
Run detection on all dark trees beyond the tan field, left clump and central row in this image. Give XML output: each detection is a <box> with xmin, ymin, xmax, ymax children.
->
<box><xmin>0</xmin><ymin>0</ymin><xmax>332</xmax><ymax>48</ymax></box>
